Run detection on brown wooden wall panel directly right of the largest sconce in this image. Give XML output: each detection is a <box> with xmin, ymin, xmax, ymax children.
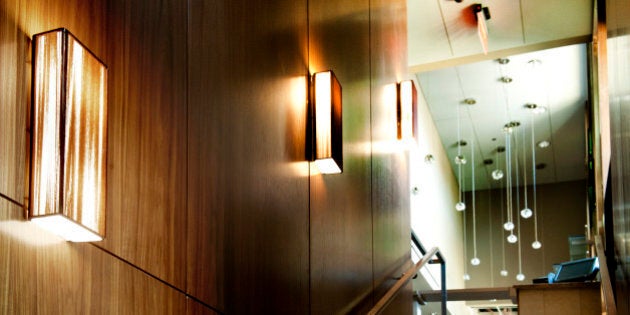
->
<box><xmin>99</xmin><ymin>1</ymin><xmax>187</xmax><ymax>290</ymax></box>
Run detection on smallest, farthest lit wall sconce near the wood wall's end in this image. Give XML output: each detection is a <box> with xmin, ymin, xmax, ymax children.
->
<box><xmin>396</xmin><ymin>80</ymin><xmax>418</xmax><ymax>140</ymax></box>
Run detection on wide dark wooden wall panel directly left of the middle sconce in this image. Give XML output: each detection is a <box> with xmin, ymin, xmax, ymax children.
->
<box><xmin>187</xmin><ymin>0</ymin><xmax>309</xmax><ymax>314</ymax></box>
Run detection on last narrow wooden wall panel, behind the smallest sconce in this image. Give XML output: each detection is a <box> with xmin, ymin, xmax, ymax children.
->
<box><xmin>370</xmin><ymin>1</ymin><xmax>411</xmax><ymax>301</ymax></box>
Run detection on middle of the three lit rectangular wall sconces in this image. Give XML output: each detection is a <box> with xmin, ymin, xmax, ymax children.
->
<box><xmin>311</xmin><ymin>71</ymin><xmax>343</xmax><ymax>174</ymax></box>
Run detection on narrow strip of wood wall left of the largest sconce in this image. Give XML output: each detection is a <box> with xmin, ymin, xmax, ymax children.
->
<box><xmin>0</xmin><ymin>0</ymin><xmax>30</xmax><ymax>203</ymax></box>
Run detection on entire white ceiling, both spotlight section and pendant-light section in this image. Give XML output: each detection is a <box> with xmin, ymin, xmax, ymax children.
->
<box><xmin>408</xmin><ymin>0</ymin><xmax>592</xmax><ymax>191</ymax></box>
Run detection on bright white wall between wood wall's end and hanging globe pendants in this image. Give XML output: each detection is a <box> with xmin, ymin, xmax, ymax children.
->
<box><xmin>409</xmin><ymin>80</ymin><xmax>466</xmax><ymax>314</ymax></box>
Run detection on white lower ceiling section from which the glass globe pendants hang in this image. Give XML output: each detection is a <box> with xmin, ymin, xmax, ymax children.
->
<box><xmin>417</xmin><ymin>44</ymin><xmax>587</xmax><ymax>190</ymax></box>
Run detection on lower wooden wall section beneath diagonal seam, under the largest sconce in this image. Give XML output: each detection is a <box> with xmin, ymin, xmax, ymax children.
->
<box><xmin>0</xmin><ymin>198</ymin><xmax>213</xmax><ymax>314</ymax></box>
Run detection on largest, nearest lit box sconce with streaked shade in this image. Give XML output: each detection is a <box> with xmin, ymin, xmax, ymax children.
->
<box><xmin>29</xmin><ymin>29</ymin><xmax>107</xmax><ymax>242</ymax></box>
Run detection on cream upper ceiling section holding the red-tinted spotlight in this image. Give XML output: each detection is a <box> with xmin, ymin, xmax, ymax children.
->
<box><xmin>407</xmin><ymin>0</ymin><xmax>596</xmax><ymax>69</ymax></box>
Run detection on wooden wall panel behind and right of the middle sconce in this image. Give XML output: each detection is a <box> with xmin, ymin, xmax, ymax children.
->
<box><xmin>308</xmin><ymin>0</ymin><xmax>373</xmax><ymax>314</ymax></box>
